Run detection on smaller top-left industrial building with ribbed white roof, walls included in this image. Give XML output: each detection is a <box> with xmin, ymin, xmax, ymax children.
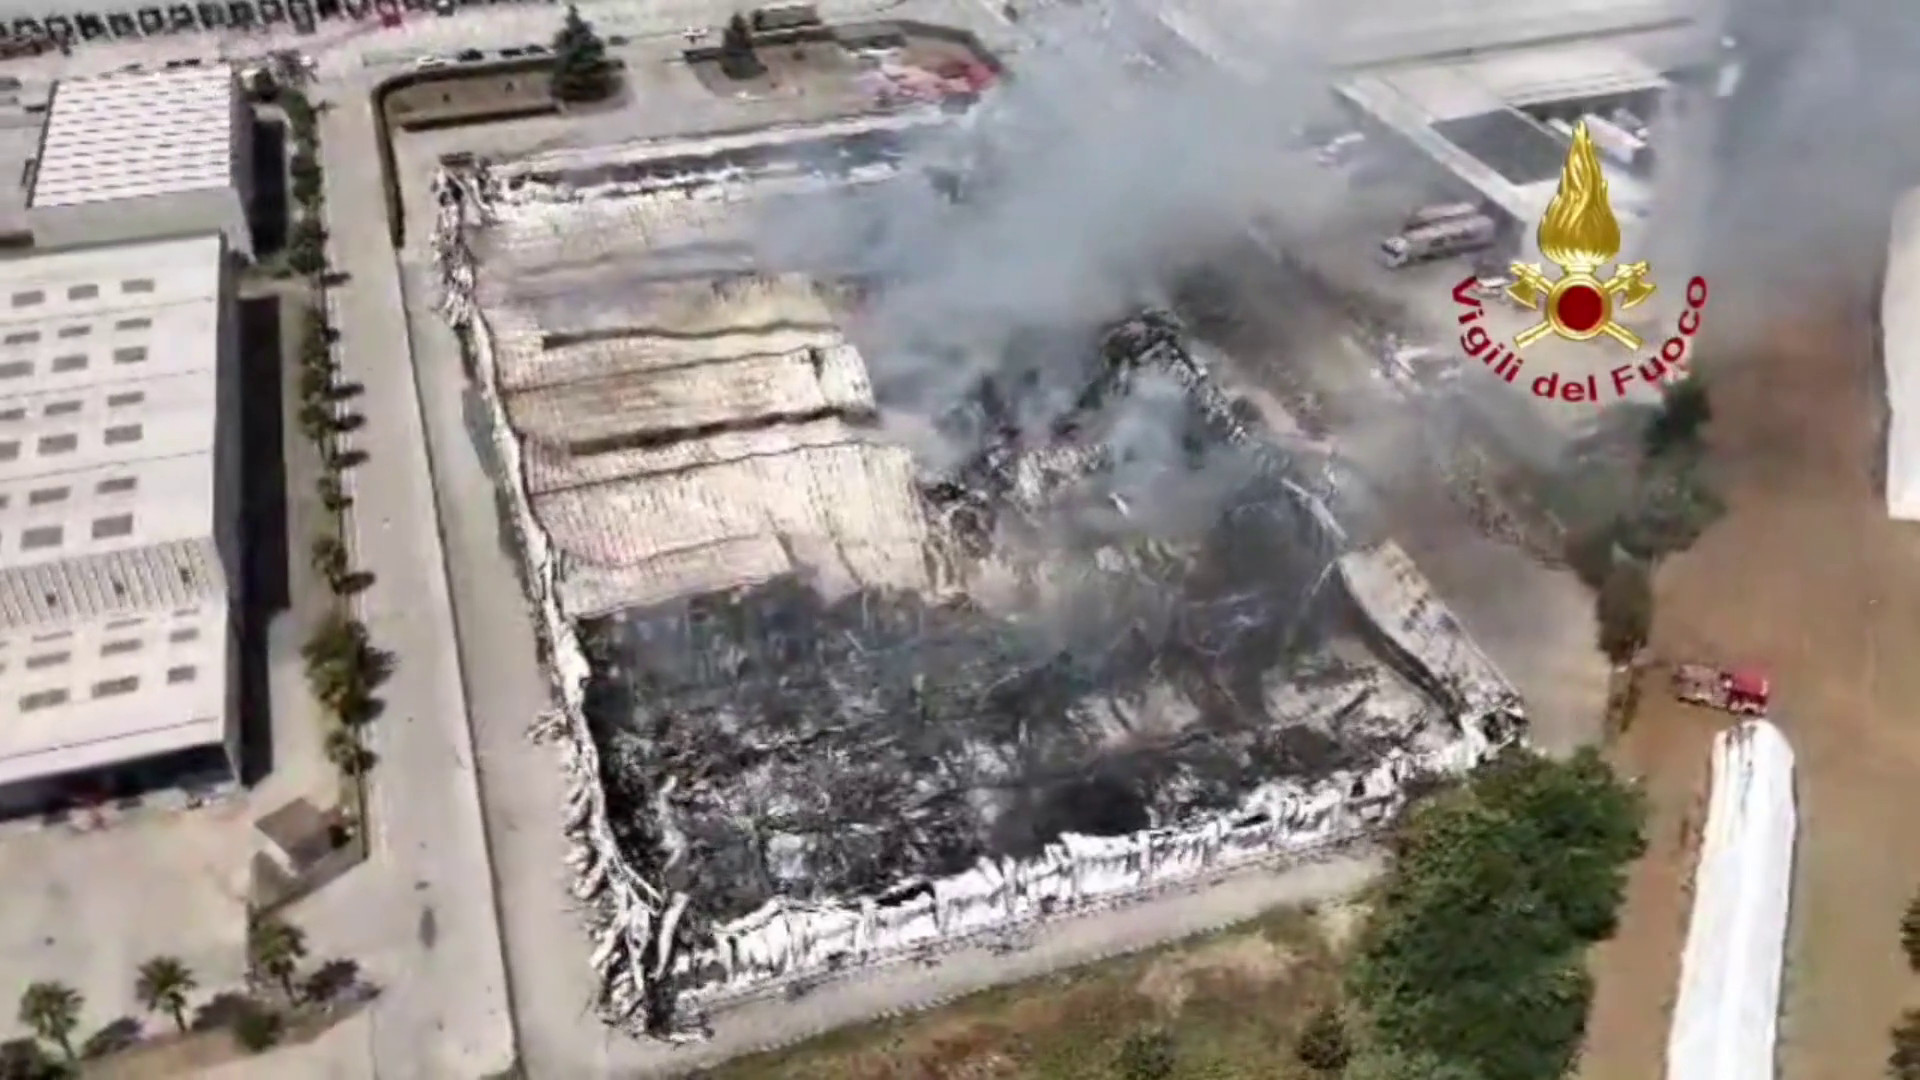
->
<box><xmin>27</xmin><ymin>63</ymin><xmax>253</xmax><ymax>258</ymax></box>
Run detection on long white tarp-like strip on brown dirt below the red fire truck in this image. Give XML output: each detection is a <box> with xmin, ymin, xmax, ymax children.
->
<box><xmin>1667</xmin><ymin>721</ymin><xmax>1797</xmax><ymax>1080</ymax></box>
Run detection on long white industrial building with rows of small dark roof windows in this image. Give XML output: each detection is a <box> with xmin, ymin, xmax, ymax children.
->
<box><xmin>0</xmin><ymin>233</ymin><xmax>240</xmax><ymax>809</ymax></box>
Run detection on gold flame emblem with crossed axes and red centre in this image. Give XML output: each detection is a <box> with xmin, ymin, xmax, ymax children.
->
<box><xmin>1507</xmin><ymin>121</ymin><xmax>1655</xmax><ymax>348</ymax></box>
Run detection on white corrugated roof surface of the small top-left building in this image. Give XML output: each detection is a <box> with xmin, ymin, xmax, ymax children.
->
<box><xmin>27</xmin><ymin>65</ymin><xmax>240</xmax><ymax>208</ymax></box>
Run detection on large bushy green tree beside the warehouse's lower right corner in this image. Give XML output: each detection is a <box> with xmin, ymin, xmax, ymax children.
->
<box><xmin>1348</xmin><ymin>749</ymin><xmax>1644</xmax><ymax>1080</ymax></box>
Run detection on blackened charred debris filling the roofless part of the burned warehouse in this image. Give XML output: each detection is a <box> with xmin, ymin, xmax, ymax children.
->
<box><xmin>582</xmin><ymin>311</ymin><xmax>1392</xmax><ymax>933</ymax></box>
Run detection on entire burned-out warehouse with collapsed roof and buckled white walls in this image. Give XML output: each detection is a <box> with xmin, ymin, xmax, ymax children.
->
<box><xmin>434</xmin><ymin>115</ymin><xmax>1521</xmax><ymax>1032</ymax></box>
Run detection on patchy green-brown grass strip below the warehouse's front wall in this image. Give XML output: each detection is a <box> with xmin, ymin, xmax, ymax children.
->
<box><xmin>708</xmin><ymin>907</ymin><xmax>1357</xmax><ymax>1080</ymax></box>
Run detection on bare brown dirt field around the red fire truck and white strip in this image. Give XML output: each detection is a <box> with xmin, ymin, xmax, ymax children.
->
<box><xmin>1582</xmin><ymin>267</ymin><xmax>1920</xmax><ymax>1080</ymax></box>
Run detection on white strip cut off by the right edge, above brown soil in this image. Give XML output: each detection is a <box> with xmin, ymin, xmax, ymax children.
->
<box><xmin>1880</xmin><ymin>190</ymin><xmax>1920</xmax><ymax>521</ymax></box>
